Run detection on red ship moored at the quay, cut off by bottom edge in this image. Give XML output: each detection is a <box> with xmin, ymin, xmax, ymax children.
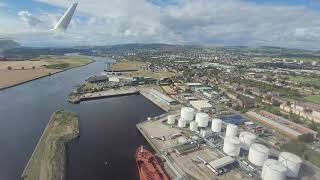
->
<box><xmin>136</xmin><ymin>146</ymin><xmax>169</xmax><ymax>180</ymax></box>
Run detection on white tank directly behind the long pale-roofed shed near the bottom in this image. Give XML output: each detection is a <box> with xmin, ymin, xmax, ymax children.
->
<box><xmin>223</xmin><ymin>137</ymin><xmax>240</xmax><ymax>156</ymax></box>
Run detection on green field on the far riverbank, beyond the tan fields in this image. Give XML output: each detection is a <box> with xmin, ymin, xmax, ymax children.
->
<box><xmin>43</xmin><ymin>56</ymin><xmax>92</xmax><ymax>69</ymax></box>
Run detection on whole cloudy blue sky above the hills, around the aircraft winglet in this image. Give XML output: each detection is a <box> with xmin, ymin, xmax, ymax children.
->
<box><xmin>0</xmin><ymin>0</ymin><xmax>320</xmax><ymax>50</ymax></box>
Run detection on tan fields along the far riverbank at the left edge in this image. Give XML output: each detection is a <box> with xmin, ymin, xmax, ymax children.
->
<box><xmin>0</xmin><ymin>58</ymin><xmax>95</xmax><ymax>91</ymax></box>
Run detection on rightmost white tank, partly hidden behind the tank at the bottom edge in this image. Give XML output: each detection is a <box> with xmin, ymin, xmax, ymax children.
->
<box><xmin>279</xmin><ymin>152</ymin><xmax>302</xmax><ymax>177</ymax></box>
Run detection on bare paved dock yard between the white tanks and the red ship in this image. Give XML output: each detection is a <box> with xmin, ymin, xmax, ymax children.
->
<box><xmin>136</xmin><ymin>115</ymin><xmax>248</xmax><ymax>180</ymax></box>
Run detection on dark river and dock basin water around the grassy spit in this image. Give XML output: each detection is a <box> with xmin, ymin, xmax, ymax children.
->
<box><xmin>0</xmin><ymin>58</ymin><xmax>163</xmax><ymax>180</ymax></box>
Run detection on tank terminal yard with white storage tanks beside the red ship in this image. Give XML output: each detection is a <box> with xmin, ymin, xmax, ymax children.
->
<box><xmin>137</xmin><ymin>89</ymin><xmax>320</xmax><ymax>180</ymax></box>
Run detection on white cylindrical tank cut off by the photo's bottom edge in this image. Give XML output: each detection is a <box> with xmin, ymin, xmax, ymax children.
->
<box><xmin>261</xmin><ymin>159</ymin><xmax>287</xmax><ymax>180</ymax></box>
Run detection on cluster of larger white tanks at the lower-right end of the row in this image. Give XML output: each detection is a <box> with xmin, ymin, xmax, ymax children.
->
<box><xmin>223</xmin><ymin>124</ymin><xmax>302</xmax><ymax>180</ymax></box>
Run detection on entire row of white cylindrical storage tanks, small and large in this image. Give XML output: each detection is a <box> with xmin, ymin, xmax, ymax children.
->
<box><xmin>167</xmin><ymin>107</ymin><xmax>302</xmax><ymax>180</ymax></box>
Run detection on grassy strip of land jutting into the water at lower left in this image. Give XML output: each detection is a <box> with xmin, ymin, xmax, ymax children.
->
<box><xmin>22</xmin><ymin>111</ymin><xmax>79</xmax><ymax>180</ymax></box>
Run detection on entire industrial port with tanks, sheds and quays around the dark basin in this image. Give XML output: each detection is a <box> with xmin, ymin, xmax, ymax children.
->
<box><xmin>64</xmin><ymin>58</ymin><xmax>320</xmax><ymax>180</ymax></box>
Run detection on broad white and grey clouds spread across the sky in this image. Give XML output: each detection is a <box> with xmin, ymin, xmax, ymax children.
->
<box><xmin>2</xmin><ymin>0</ymin><xmax>320</xmax><ymax>48</ymax></box>
